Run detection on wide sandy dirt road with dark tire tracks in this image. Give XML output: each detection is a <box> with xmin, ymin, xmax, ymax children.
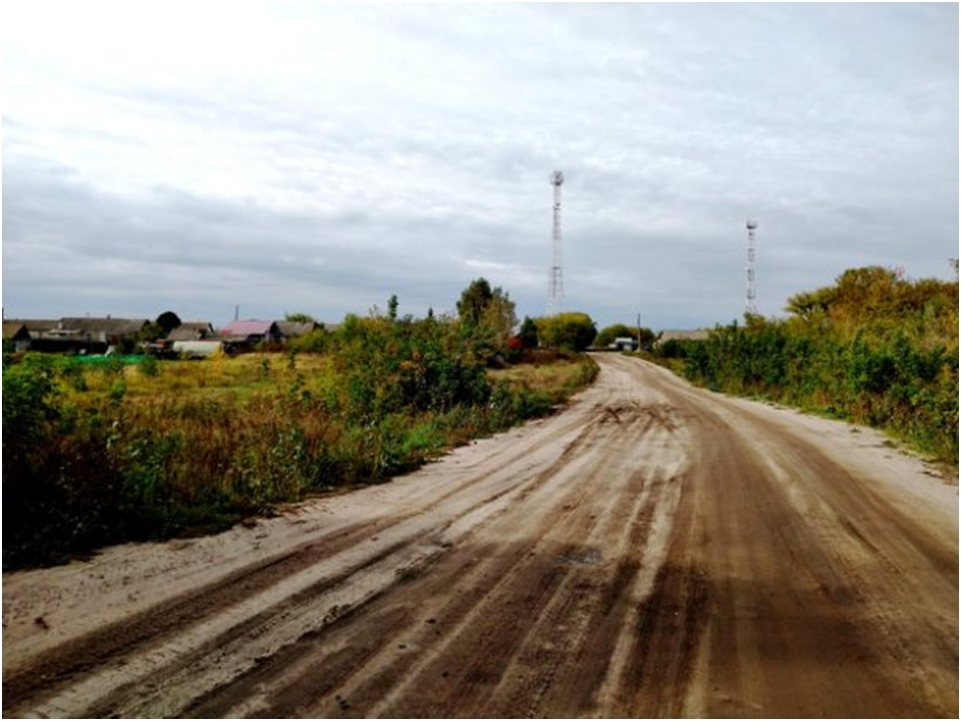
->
<box><xmin>2</xmin><ymin>357</ymin><xmax>958</xmax><ymax>718</ymax></box>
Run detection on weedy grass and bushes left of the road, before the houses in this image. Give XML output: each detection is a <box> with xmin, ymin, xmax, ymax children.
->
<box><xmin>2</xmin><ymin>281</ymin><xmax>597</xmax><ymax>571</ymax></box>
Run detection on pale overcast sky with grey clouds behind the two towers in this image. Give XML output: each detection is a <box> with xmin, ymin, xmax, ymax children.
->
<box><xmin>2</xmin><ymin>2</ymin><xmax>959</xmax><ymax>328</ymax></box>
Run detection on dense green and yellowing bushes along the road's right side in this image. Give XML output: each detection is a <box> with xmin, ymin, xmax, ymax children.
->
<box><xmin>680</xmin><ymin>263</ymin><xmax>958</xmax><ymax>468</ymax></box>
